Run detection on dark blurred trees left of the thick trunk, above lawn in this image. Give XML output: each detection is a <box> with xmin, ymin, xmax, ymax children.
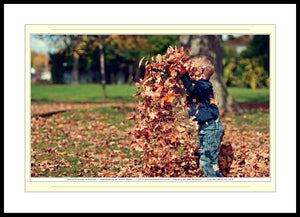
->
<box><xmin>36</xmin><ymin>35</ymin><xmax>178</xmax><ymax>84</ymax></box>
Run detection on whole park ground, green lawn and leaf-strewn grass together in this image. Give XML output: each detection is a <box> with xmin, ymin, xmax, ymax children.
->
<box><xmin>31</xmin><ymin>85</ymin><xmax>270</xmax><ymax>177</ymax></box>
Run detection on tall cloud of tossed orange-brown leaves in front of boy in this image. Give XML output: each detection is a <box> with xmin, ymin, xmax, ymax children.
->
<box><xmin>130</xmin><ymin>47</ymin><xmax>209</xmax><ymax>177</ymax></box>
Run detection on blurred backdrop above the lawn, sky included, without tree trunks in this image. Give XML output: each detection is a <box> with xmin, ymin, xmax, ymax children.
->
<box><xmin>31</xmin><ymin>35</ymin><xmax>269</xmax><ymax>88</ymax></box>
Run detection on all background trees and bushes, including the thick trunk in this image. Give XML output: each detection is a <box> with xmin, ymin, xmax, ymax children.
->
<box><xmin>33</xmin><ymin>35</ymin><xmax>269</xmax><ymax>112</ymax></box>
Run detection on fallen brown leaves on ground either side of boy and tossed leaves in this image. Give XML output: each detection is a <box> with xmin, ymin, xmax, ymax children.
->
<box><xmin>31</xmin><ymin>104</ymin><xmax>270</xmax><ymax>177</ymax></box>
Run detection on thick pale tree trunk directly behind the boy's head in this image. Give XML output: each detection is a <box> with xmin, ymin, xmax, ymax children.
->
<box><xmin>179</xmin><ymin>35</ymin><xmax>244</xmax><ymax>112</ymax></box>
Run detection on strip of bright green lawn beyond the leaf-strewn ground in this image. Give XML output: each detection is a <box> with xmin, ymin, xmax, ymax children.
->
<box><xmin>31</xmin><ymin>84</ymin><xmax>269</xmax><ymax>102</ymax></box>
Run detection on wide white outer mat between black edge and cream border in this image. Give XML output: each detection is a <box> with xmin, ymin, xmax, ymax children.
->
<box><xmin>4</xmin><ymin>3</ymin><xmax>296</xmax><ymax>213</ymax></box>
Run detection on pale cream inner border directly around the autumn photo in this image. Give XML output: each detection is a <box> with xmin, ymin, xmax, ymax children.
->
<box><xmin>25</xmin><ymin>24</ymin><xmax>275</xmax><ymax>192</ymax></box>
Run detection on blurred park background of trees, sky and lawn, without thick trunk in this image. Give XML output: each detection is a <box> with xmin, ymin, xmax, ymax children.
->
<box><xmin>30</xmin><ymin>34</ymin><xmax>269</xmax><ymax>110</ymax></box>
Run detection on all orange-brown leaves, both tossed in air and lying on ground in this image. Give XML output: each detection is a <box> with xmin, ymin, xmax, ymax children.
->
<box><xmin>30</xmin><ymin>47</ymin><xmax>270</xmax><ymax>178</ymax></box>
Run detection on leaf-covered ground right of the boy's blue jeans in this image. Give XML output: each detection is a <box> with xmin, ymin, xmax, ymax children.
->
<box><xmin>218</xmin><ymin>123</ymin><xmax>270</xmax><ymax>177</ymax></box>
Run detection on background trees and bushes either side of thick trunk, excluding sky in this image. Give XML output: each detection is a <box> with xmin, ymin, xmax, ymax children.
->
<box><xmin>32</xmin><ymin>35</ymin><xmax>269</xmax><ymax>88</ymax></box>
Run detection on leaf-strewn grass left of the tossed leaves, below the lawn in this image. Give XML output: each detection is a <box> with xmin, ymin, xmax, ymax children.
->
<box><xmin>31</xmin><ymin>107</ymin><xmax>142</xmax><ymax>177</ymax></box>
